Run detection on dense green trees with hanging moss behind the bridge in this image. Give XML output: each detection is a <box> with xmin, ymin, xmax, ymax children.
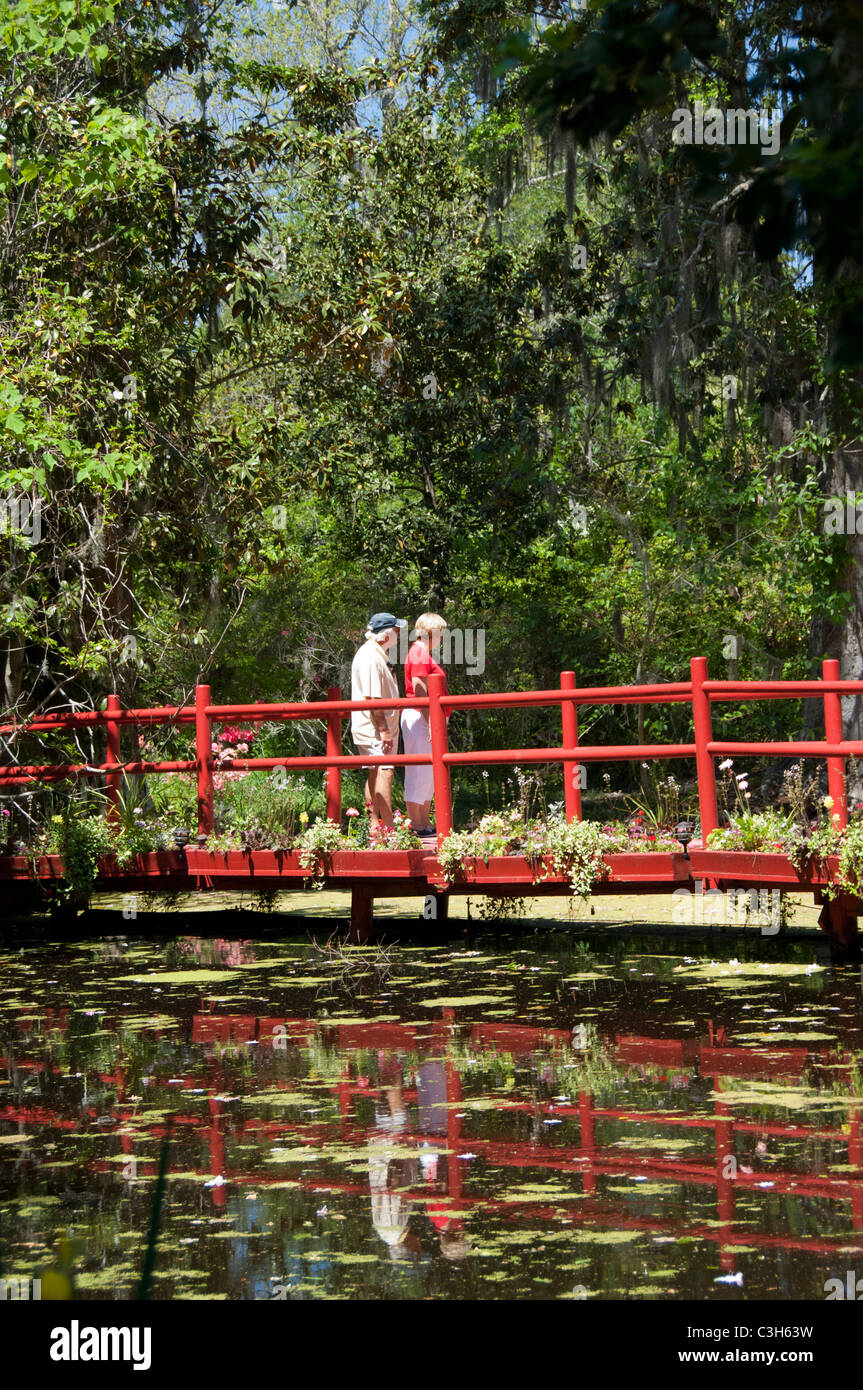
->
<box><xmin>0</xmin><ymin>0</ymin><xmax>863</xmax><ymax>783</ymax></box>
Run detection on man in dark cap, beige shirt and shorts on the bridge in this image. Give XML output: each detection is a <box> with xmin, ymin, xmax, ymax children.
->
<box><xmin>350</xmin><ymin>613</ymin><xmax>407</xmax><ymax>830</ymax></box>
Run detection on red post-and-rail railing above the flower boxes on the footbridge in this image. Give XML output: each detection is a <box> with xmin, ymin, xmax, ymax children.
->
<box><xmin>0</xmin><ymin>656</ymin><xmax>863</xmax><ymax>838</ymax></box>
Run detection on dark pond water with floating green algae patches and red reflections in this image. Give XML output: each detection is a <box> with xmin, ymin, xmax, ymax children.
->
<box><xmin>0</xmin><ymin>933</ymin><xmax>863</xmax><ymax>1300</ymax></box>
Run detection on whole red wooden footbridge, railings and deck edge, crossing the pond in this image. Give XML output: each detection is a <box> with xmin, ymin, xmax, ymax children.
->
<box><xmin>0</xmin><ymin>656</ymin><xmax>863</xmax><ymax>955</ymax></box>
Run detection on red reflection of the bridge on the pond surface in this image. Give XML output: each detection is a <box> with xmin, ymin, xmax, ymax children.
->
<box><xmin>0</xmin><ymin>1008</ymin><xmax>863</xmax><ymax>1270</ymax></box>
